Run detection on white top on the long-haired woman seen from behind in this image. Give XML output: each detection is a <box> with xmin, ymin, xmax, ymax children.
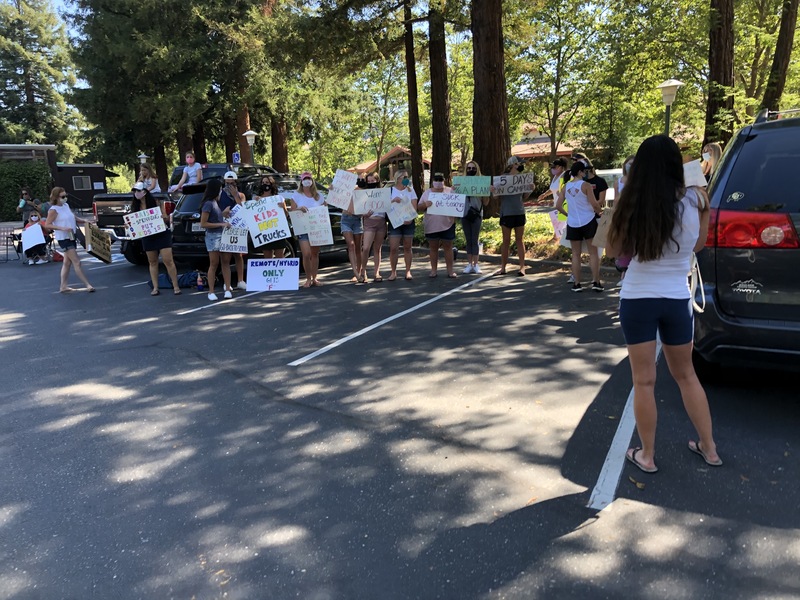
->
<box><xmin>619</xmin><ymin>190</ymin><xmax>700</xmax><ymax>300</ymax></box>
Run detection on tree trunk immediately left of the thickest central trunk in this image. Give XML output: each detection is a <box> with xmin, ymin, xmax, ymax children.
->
<box><xmin>428</xmin><ymin>1</ymin><xmax>453</xmax><ymax>181</ymax></box>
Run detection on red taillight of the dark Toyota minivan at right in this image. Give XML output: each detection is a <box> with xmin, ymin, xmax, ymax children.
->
<box><xmin>706</xmin><ymin>210</ymin><xmax>800</xmax><ymax>248</ymax></box>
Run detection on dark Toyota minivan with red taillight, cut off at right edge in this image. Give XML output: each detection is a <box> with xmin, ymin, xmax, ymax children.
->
<box><xmin>695</xmin><ymin>110</ymin><xmax>800</xmax><ymax>368</ymax></box>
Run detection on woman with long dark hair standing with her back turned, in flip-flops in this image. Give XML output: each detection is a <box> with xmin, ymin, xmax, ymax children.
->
<box><xmin>606</xmin><ymin>135</ymin><xmax>722</xmax><ymax>473</ymax></box>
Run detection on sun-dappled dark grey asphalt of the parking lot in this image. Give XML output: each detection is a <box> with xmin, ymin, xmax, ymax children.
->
<box><xmin>0</xmin><ymin>246</ymin><xmax>800</xmax><ymax>599</ymax></box>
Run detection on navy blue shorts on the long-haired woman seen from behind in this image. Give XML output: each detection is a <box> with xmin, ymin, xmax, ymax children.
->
<box><xmin>619</xmin><ymin>298</ymin><xmax>694</xmax><ymax>346</ymax></box>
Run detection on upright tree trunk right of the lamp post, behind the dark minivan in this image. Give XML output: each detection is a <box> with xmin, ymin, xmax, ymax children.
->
<box><xmin>703</xmin><ymin>0</ymin><xmax>733</xmax><ymax>145</ymax></box>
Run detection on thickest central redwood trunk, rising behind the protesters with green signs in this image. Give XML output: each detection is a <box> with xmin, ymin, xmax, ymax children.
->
<box><xmin>471</xmin><ymin>0</ymin><xmax>511</xmax><ymax>215</ymax></box>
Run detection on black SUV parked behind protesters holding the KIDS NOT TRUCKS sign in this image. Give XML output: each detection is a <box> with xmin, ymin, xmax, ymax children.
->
<box><xmin>172</xmin><ymin>175</ymin><xmax>340</xmax><ymax>262</ymax></box>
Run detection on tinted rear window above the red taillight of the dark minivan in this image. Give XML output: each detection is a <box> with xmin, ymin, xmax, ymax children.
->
<box><xmin>720</xmin><ymin>127</ymin><xmax>800</xmax><ymax>212</ymax></box>
